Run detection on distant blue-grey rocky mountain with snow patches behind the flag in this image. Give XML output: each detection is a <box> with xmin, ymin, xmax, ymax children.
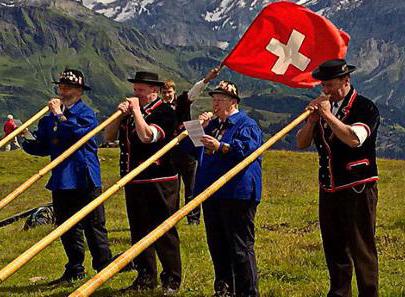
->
<box><xmin>78</xmin><ymin>0</ymin><xmax>405</xmax><ymax>157</ymax></box>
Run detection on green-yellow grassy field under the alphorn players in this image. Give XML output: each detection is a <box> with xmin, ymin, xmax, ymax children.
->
<box><xmin>0</xmin><ymin>149</ymin><xmax>405</xmax><ymax>297</ymax></box>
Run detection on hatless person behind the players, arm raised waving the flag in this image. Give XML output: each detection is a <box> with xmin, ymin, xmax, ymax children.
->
<box><xmin>162</xmin><ymin>67</ymin><xmax>219</xmax><ymax>225</ymax></box>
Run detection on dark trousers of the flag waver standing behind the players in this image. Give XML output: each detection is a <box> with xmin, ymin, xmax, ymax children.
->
<box><xmin>172</xmin><ymin>147</ymin><xmax>201</xmax><ymax>222</ymax></box>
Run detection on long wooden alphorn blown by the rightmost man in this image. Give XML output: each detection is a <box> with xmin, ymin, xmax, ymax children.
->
<box><xmin>69</xmin><ymin>110</ymin><xmax>312</xmax><ymax>297</ymax></box>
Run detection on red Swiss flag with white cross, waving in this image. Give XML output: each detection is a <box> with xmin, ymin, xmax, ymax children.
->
<box><xmin>222</xmin><ymin>1</ymin><xmax>350</xmax><ymax>88</ymax></box>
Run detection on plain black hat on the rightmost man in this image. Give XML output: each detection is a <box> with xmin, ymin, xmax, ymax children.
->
<box><xmin>312</xmin><ymin>59</ymin><xmax>356</xmax><ymax>80</ymax></box>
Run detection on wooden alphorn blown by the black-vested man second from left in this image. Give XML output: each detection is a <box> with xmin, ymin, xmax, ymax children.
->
<box><xmin>0</xmin><ymin>111</ymin><xmax>122</xmax><ymax>209</ymax></box>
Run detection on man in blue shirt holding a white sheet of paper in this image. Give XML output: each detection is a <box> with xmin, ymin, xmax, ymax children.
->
<box><xmin>195</xmin><ymin>81</ymin><xmax>263</xmax><ymax>297</ymax></box>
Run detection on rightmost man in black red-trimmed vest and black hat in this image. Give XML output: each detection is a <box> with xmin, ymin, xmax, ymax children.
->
<box><xmin>297</xmin><ymin>59</ymin><xmax>380</xmax><ymax>297</ymax></box>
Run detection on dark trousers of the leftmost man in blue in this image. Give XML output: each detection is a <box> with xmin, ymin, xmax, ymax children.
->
<box><xmin>52</xmin><ymin>188</ymin><xmax>111</xmax><ymax>273</ymax></box>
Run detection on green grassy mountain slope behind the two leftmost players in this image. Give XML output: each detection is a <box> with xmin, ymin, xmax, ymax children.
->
<box><xmin>0</xmin><ymin>0</ymin><xmax>218</xmax><ymax>118</ymax></box>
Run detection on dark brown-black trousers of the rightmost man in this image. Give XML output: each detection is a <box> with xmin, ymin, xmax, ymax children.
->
<box><xmin>319</xmin><ymin>183</ymin><xmax>378</xmax><ymax>297</ymax></box>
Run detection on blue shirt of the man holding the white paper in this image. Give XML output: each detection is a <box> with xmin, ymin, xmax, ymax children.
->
<box><xmin>194</xmin><ymin>111</ymin><xmax>263</xmax><ymax>202</ymax></box>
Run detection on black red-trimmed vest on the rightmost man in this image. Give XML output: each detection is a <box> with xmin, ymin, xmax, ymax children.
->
<box><xmin>314</xmin><ymin>87</ymin><xmax>380</xmax><ymax>192</ymax></box>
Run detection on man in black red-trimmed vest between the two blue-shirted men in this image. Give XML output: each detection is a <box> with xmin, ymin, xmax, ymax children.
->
<box><xmin>106</xmin><ymin>71</ymin><xmax>181</xmax><ymax>294</ymax></box>
